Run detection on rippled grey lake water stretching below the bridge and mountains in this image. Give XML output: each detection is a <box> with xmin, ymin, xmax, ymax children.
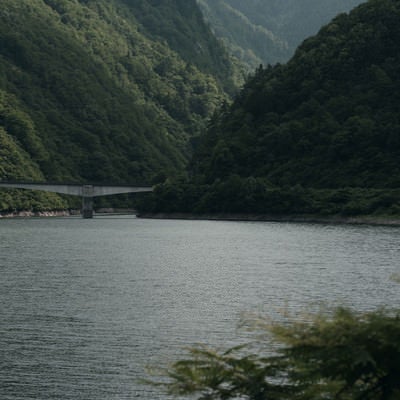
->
<box><xmin>0</xmin><ymin>217</ymin><xmax>400</xmax><ymax>400</ymax></box>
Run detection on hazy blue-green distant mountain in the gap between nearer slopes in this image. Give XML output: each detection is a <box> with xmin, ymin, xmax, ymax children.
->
<box><xmin>198</xmin><ymin>0</ymin><xmax>363</xmax><ymax>69</ymax></box>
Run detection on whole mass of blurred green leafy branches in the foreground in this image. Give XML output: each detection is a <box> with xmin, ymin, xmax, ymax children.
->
<box><xmin>149</xmin><ymin>308</ymin><xmax>400</xmax><ymax>400</ymax></box>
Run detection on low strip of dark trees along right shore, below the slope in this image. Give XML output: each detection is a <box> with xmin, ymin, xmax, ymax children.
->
<box><xmin>138</xmin><ymin>175</ymin><xmax>400</xmax><ymax>219</ymax></box>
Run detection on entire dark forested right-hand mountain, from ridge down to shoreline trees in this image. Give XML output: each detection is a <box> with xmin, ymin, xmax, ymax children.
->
<box><xmin>143</xmin><ymin>0</ymin><xmax>400</xmax><ymax>215</ymax></box>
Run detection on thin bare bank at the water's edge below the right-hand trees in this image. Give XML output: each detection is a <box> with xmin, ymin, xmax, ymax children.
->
<box><xmin>137</xmin><ymin>213</ymin><xmax>400</xmax><ymax>226</ymax></box>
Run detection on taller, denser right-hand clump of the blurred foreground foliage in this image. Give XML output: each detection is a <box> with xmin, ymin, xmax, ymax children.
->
<box><xmin>271</xmin><ymin>308</ymin><xmax>400</xmax><ymax>400</ymax></box>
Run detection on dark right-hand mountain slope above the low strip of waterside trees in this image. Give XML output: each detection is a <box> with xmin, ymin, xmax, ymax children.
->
<box><xmin>196</xmin><ymin>0</ymin><xmax>400</xmax><ymax>187</ymax></box>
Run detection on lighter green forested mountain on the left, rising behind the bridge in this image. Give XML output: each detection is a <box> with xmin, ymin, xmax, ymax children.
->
<box><xmin>0</xmin><ymin>0</ymin><xmax>235</xmax><ymax>208</ymax></box>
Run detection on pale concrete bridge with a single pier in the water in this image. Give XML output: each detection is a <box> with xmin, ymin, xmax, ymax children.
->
<box><xmin>0</xmin><ymin>181</ymin><xmax>153</xmax><ymax>218</ymax></box>
